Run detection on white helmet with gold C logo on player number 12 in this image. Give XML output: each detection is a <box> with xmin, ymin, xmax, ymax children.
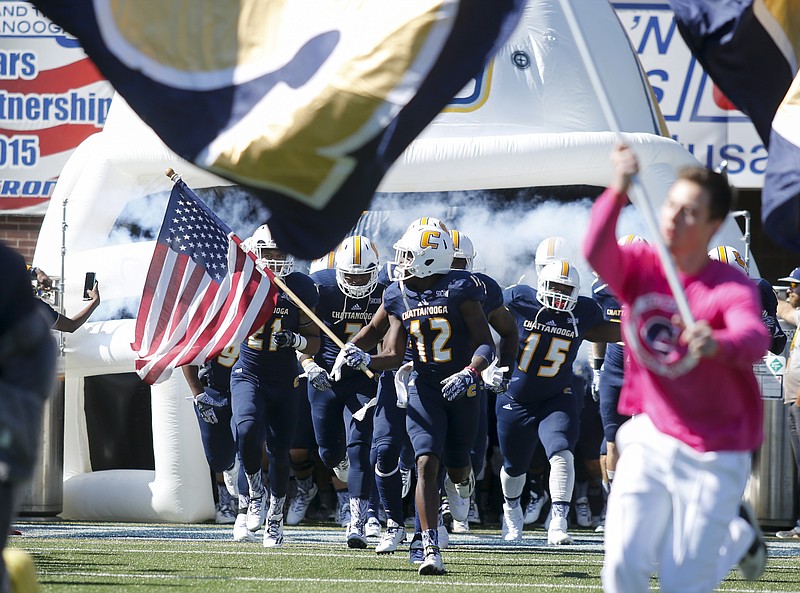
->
<box><xmin>394</xmin><ymin>225</ymin><xmax>454</xmax><ymax>280</ymax></box>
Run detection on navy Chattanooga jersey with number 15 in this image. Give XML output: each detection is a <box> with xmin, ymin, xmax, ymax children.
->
<box><xmin>503</xmin><ymin>284</ymin><xmax>603</xmax><ymax>402</ymax></box>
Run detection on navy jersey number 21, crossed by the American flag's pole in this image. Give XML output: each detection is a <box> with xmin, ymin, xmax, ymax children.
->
<box><xmin>234</xmin><ymin>272</ymin><xmax>319</xmax><ymax>384</ymax></box>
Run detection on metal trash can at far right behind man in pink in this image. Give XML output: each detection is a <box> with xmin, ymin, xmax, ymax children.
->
<box><xmin>745</xmin><ymin>354</ymin><xmax>798</xmax><ymax>527</ymax></box>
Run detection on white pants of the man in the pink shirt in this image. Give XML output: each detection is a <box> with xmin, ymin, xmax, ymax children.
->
<box><xmin>602</xmin><ymin>415</ymin><xmax>756</xmax><ymax>593</ymax></box>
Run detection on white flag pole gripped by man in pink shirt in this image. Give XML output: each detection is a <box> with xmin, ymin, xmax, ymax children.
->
<box><xmin>561</xmin><ymin>0</ymin><xmax>695</xmax><ymax>328</ymax></box>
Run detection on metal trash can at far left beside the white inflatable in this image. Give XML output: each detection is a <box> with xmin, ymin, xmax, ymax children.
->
<box><xmin>17</xmin><ymin>356</ymin><xmax>64</xmax><ymax>517</ymax></box>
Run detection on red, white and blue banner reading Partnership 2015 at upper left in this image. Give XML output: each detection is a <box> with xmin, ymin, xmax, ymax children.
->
<box><xmin>0</xmin><ymin>0</ymin><xmax>114</xmax><ymax>215</ymax></box>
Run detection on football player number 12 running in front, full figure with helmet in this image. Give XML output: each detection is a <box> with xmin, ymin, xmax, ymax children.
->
<box><xmin>344</xmin><ymin>225</ymin><xmax>495</xmax><ymax>575</ymax></box>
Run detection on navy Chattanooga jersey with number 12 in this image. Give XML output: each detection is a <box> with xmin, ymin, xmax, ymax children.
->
<box><xmin>383</xmin><ymin>270</ymin><xmax>486</xmax><ymax>386</ymax></box>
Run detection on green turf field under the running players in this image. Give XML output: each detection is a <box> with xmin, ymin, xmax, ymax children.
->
<box><xmin>9</xmin><ymin>521</ymin><xmax>800</xmax><ymax>593</ymax></box>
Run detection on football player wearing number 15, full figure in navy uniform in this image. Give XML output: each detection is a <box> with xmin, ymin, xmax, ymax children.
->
<box><xmin>495</xmin><ymin>260</ymin><xmax>619</xmax><ymax>545</ymax></box>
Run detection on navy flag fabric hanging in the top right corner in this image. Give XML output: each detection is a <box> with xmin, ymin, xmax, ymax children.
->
<box><xmin>669</xmin><ymin>0</ymin><xmax>800</xmax><ymax>251</ymax></box>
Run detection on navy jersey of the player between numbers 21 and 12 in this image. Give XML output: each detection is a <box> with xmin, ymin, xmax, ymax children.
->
<box><xmin>311</xmin><ymin>270</ymin><xmax>386</xmax><ymax>376</ymax></box>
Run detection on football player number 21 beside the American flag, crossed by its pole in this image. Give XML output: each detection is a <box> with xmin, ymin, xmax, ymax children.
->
<box><xmin>231</xmin><ymin>225</ymin><xmax>320</xmax><ymax>548</ymax></box>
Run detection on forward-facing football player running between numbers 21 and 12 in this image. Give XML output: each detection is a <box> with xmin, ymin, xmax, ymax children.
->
<box><xmin>301</xmin><ymin>235</ymin><xmax>385</xmax><ymax>549</ymax></box>
